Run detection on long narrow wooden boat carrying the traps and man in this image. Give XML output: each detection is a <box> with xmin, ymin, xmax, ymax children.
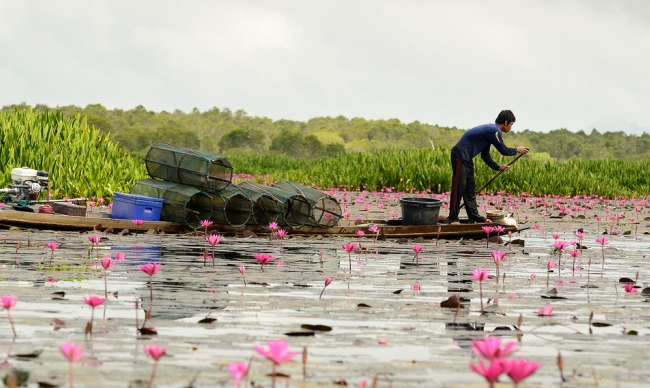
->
<box><xmin>0</xmin><ymin>210</ymin><xmax>528</xmax><ymax>239</ymax></box>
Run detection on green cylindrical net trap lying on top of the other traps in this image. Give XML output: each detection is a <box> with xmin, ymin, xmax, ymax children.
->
<box><xmin>144</xmin><ymin>144</ymin><xmax>232</xmax><ymax>191</ymax></box>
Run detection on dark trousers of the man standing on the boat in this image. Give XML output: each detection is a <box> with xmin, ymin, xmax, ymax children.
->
<box><xmin>448</xmin><ymin>153</ymin><xmax>485</xmax><ymax>222</ymax></box>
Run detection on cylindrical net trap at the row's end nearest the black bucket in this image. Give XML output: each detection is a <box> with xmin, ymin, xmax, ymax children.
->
<box><xmin>273</xmin><ymin>181</ymin><xmax>343</xmax><ymax>228</ymax></box>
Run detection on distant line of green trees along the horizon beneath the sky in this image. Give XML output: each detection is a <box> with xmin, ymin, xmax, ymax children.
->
<box><xmin>2</xmin><ymin>103</ymin><xmax>650</xmax><ymax>160</ymax></box>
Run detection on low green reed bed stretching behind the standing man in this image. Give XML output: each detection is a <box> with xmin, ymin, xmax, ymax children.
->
<box><xmin>231</xmin><ymin>149</ymin><xmax>650</xmax><ymax>197</ymax></box>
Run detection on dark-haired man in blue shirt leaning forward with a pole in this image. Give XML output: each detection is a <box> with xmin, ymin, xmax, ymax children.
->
<box><xmin>447</xmin><ymin>110</ymin><xmax>529</xmax><ymax>224</ymax></box>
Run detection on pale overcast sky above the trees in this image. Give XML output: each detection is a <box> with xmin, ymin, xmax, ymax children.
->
<box><xmin>0</xmin><ymin>0</ymin><xmax>650</xmax><ymax>134</ymax></box>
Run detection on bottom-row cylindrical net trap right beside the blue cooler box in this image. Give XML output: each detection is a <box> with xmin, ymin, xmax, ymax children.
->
<box><xmin>131</xmin><ymin>179</ymin><xmax>213</xmax><ymax>229</ymax></box>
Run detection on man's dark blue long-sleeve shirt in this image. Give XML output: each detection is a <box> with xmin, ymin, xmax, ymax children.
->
<box><xmin>451</xmin><ymin>124</ymin><xmax>517</xmax><ymax>170</ymax></box>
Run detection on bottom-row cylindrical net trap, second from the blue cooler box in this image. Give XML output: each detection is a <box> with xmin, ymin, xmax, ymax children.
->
<box><xmin>207</xmin><ymin>184</ymin><xmax>253</xmax><ymax>228</ymax></box>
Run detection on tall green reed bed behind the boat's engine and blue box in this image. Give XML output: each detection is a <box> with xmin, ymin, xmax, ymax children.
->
<box><xmin>0</xmin><ymin>110</ymin><xmax>146</xmax><ymax>198</ymax></box>
